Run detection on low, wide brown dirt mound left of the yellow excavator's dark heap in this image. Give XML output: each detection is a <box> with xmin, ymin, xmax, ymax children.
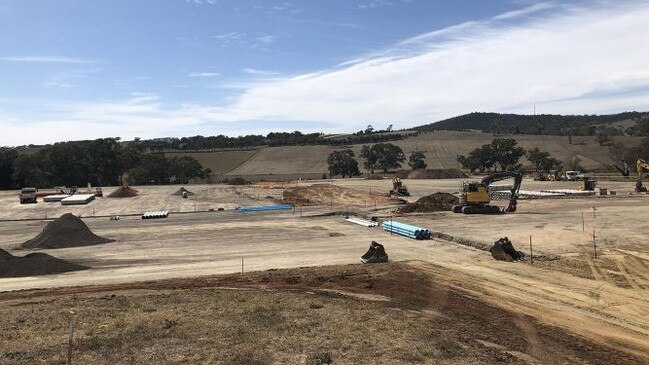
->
<box><xmin>282</xmin><ymin>184</ymin><xmax>390</xmax><ymax>206</ymax></box>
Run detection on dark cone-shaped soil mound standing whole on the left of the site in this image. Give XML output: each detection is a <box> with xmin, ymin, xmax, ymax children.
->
<box><xmin>22</xmin><ymin>213</ymin><xmax>112</xmax><ymax>248</ymax></box>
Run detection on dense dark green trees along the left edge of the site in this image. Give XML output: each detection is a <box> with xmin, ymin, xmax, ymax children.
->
<box><xmin>0</xmin><ymin>138</ymin><xmax>211</xmax><ymax>189</ymax></box>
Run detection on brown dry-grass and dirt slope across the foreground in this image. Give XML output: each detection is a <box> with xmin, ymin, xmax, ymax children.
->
<box><xmin>0</xmin><ymin>263</ymin><xmax>646</xmax><ymax>365</ymax></box>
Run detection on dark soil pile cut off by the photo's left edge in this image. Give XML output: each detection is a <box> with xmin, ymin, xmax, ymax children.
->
<box><xmin>0</xmin><ymin>249</ymin><xmax>87</xmax><ymax>278</ymax></box>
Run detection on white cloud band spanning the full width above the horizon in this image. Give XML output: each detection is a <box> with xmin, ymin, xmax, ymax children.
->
<box><xmin>0</xmin><ymin>2</ymin><xmax>649</xmax><ymax>145</ymax></box>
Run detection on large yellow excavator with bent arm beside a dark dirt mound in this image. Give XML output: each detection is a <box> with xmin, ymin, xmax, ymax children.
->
<box><xmin>451</xmin><ymin>171</ymin><xmax>523</xmax><ymax>214</ymax></box>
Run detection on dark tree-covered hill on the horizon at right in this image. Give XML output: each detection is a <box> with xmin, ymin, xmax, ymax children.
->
<box><xmin>412</xmin><ymin>112</ymin><xmax>649</xmax><ymax>136</ymax></box>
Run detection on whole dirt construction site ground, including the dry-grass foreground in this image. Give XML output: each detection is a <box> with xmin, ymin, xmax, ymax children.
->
<box><xmin>0</xmin><ymin>178</ymin><xmax>649</xmax><ymax>364</ymax></box>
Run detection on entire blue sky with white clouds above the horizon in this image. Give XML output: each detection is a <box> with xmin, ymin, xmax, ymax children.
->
<box><xmin>0</xmin><ymin>0</ymin><xmax>649</xmax><ymax>146</ymax></box>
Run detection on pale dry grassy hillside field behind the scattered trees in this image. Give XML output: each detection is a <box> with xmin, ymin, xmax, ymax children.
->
<box><xmin>221</xmin><ymin>131</ymin><xmax>641</xmax><ymax>176</ymax></box>
